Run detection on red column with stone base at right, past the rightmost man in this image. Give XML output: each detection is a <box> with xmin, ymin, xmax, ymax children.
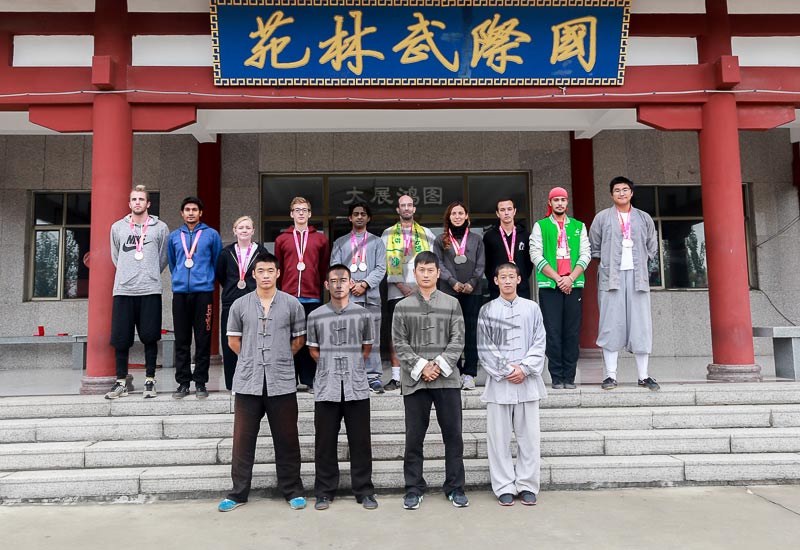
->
<box><xmin>700</xmin><ymin>94</ymin><xmax>761</xmax><ymax>382</ymax></box>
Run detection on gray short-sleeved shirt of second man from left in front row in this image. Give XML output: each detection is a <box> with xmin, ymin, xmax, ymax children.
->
<box><xmin>306</xmin><ymin>302</ymin><xmax>373</xmax><ymax>402</ymax></box>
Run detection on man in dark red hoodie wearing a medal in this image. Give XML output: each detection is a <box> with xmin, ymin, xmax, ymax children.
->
<box><xmin>275</xmin><ymin>197</ymin><xmax>331</xmax><ymax>393</ymax></box>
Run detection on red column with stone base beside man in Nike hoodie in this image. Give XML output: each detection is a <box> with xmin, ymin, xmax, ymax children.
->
<box><xmin>81</xmin><ymin>94</ymin><xmax>133</xmax><ymax>393</ymax></box>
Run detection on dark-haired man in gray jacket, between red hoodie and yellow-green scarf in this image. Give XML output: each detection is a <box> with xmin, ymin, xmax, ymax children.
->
<box><xmin>330</xmin><ymin>205</ymin><xmax>386</xmax><ymax>393</ymax></box>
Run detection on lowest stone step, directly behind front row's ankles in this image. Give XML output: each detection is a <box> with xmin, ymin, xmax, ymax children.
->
<box><xmin>0</xmin><ymin>453</ymin><xmax>800</xmax><ymax>506</ymax></box>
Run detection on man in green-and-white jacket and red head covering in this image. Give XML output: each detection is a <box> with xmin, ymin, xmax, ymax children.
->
<box><xmin>530</xmin><ymin>187</ymin><xmax>591</xmax><ymax>390</ymax></box>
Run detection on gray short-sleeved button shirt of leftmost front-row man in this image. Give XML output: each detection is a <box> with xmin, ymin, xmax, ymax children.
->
<box><xmin>227</xmin><ymin>290</ymin><xmax>306</xmax><ymax>397</ymax></box>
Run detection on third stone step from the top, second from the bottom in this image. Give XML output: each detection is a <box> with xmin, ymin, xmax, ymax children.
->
<box><xmin>0</xmin><ymin>428</ymin><xmax>800</xmax><ymax>472</ymax></box>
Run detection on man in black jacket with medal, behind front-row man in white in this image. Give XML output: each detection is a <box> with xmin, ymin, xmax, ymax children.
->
<box><xmin>483</xmin><ymin>198</ymin><xmax>533</xmax><ymax>300</ymax></box>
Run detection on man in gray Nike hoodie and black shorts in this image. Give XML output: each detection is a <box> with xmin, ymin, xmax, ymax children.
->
<box><xmin>106</xmin><ymin>185</ymin><xmax>169</xmax><ymax>399</ymax></box>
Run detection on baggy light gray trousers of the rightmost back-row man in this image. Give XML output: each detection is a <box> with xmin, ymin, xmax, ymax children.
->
<box><xmin>597</xmin><ymin>269</ymin><xmax>653</xmax><ymax>353</ymax></box>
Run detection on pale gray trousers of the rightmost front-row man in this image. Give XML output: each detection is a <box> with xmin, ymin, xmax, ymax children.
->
<box><xmin>486</xmin><ymin>401</ymin><xmax>541</xmax><ymax>497</ymax></box>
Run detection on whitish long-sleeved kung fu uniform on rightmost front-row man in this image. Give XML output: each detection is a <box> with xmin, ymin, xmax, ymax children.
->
<box><xmin>478</xmin><ymin>297</ymin><xmax>547</xmax><ymax>496</ymax></box>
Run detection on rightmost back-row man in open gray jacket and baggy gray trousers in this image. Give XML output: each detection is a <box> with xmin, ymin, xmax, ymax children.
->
<box><xmin>589</xmin><ymin>176</ymin><xmax>660</xmax><ymax>391</ymax></box>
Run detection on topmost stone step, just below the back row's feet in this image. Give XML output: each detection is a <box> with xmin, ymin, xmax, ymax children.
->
<box><xmin>0</xmin><ymin>382</ymin><xmax>800</xmax><ymax>420</ymax></box>
